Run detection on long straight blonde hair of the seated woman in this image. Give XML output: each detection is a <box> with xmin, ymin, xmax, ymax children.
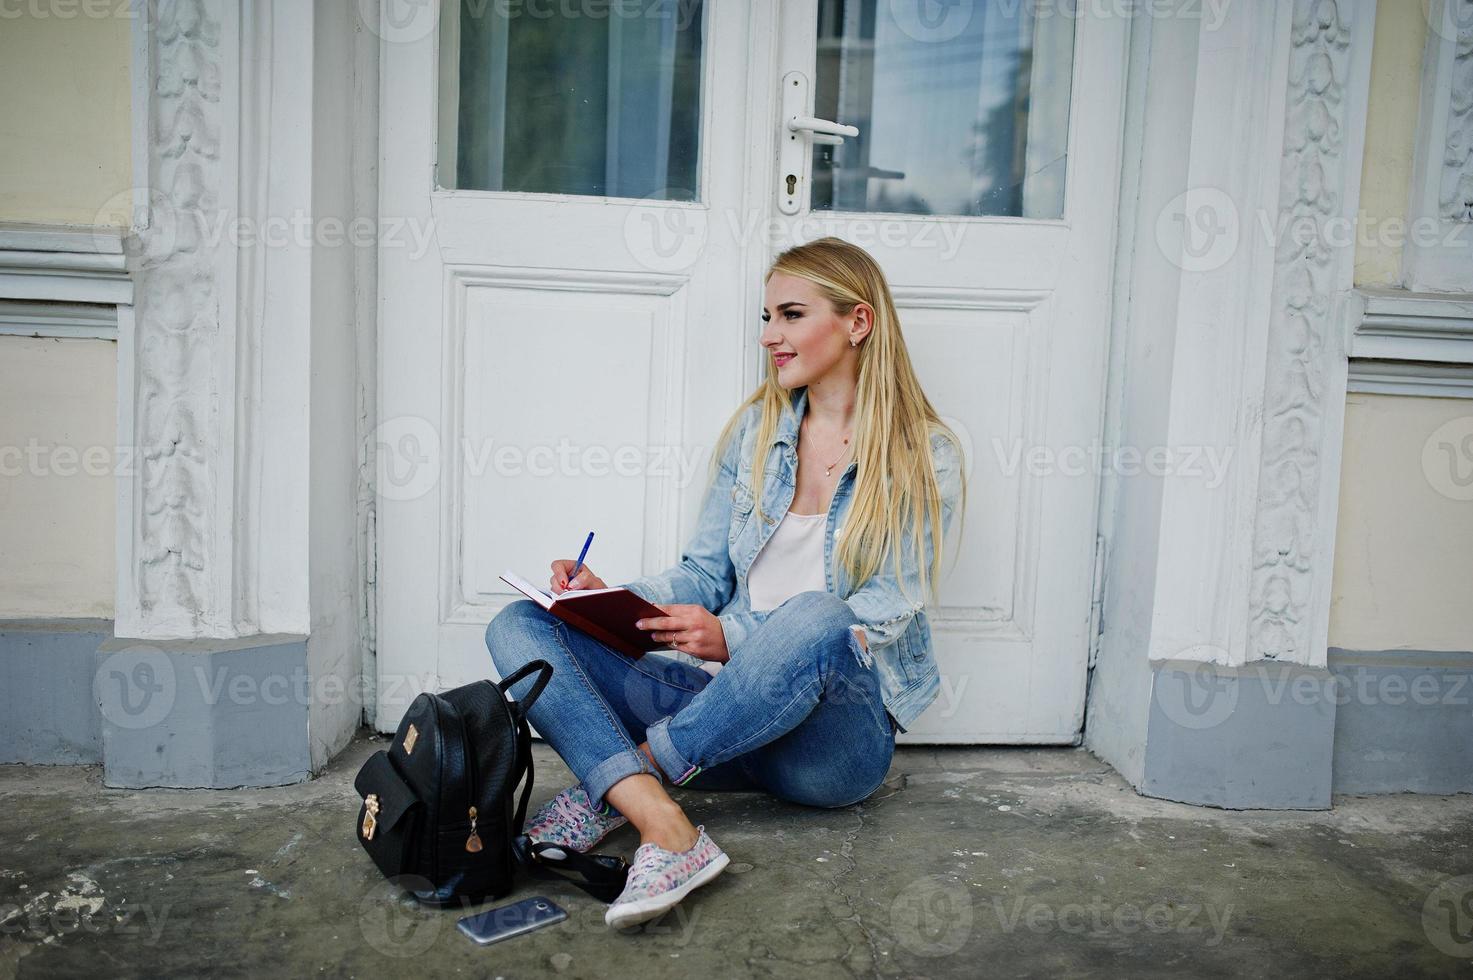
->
<box><xmin>710</xmin><ymin>237</ymin><xmax>966</xmax><ymax>600</ymax></box>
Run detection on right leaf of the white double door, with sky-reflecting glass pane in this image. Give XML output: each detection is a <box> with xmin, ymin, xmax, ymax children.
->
<box><xmin>776</xmin><ymin>0</ymin><xmax>1128</xmax><ymax>733</ymax></box>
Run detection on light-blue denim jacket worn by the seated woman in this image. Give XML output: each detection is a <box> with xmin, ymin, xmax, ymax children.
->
<box><xmin>612</xmin><ymin>386</ymin><xmax>962</xmax><ymax>731</ymax></box>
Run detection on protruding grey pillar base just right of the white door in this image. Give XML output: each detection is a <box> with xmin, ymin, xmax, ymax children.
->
<box><xmin>1139</xmin><ymin>662</ymin><xmax>1336</xmax><ymax>809</ymax></box>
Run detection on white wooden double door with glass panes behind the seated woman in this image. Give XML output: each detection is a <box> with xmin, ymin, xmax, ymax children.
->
<box><xmin>376</xmin><ymin>0</ymin><xmax>1124</xmax><ymax>743</ymax></box>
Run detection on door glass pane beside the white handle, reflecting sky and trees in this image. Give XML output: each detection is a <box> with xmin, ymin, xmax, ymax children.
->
<box><xmin>812</xmin><ymin>0</ymin><xmax>1077</xmax><ymax>218</ymax></box>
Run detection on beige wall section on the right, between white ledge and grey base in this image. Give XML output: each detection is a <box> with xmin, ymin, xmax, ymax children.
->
<box><xmin>1330</xmin><ymin>393</ymin><xmax>1473</xmax><ymax>650</ymax></box>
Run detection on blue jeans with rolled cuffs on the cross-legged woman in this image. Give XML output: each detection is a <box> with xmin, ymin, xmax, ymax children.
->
<box><xmin>486</xmin><ymin>591</ymin><xmax>896</xmax><ymax>809</ymax></box>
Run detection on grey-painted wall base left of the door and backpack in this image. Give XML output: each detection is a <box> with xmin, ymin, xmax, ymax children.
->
<box><xmin>0</xmin><ymin>620</ymin><xmax>312</xmax><ymax>787</ymax></box>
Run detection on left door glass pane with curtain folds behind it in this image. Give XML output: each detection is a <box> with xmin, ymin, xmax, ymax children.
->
<box><xmin>437</xmin><ymin>0</ymin><xmax>704</xmax><ymax>200</ymax></box>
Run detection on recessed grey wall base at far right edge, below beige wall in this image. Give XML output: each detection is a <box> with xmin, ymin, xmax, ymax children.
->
<box><xmin>1327</xmin><ymin>647</ymin><xmax>1473</xmax><ymax>794</ymax></box>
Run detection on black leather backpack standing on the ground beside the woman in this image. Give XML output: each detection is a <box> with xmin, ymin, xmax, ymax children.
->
<box><xmin>354</xmin><ymin>660</ymin><xmax>552</xmax><ymax>905</ymax></box>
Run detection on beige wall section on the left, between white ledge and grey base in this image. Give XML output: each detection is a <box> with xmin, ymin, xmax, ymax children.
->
<box><xmin>0</xmin><ymin>336</ymin><xmax>118</xmax><ymax>619</ymax></box>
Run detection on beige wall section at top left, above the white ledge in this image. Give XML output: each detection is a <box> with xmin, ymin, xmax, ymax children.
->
<box><xmin>0</xmin><ymin>8</ymin><xmax>133</xmax><ymax>224</ymax></box>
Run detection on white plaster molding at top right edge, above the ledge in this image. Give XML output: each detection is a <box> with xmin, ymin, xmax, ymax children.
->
<box><xmin>1402</xmin><ymin>0</ymin><xmax>1473</xmax><ymax>292</ymax></box>
